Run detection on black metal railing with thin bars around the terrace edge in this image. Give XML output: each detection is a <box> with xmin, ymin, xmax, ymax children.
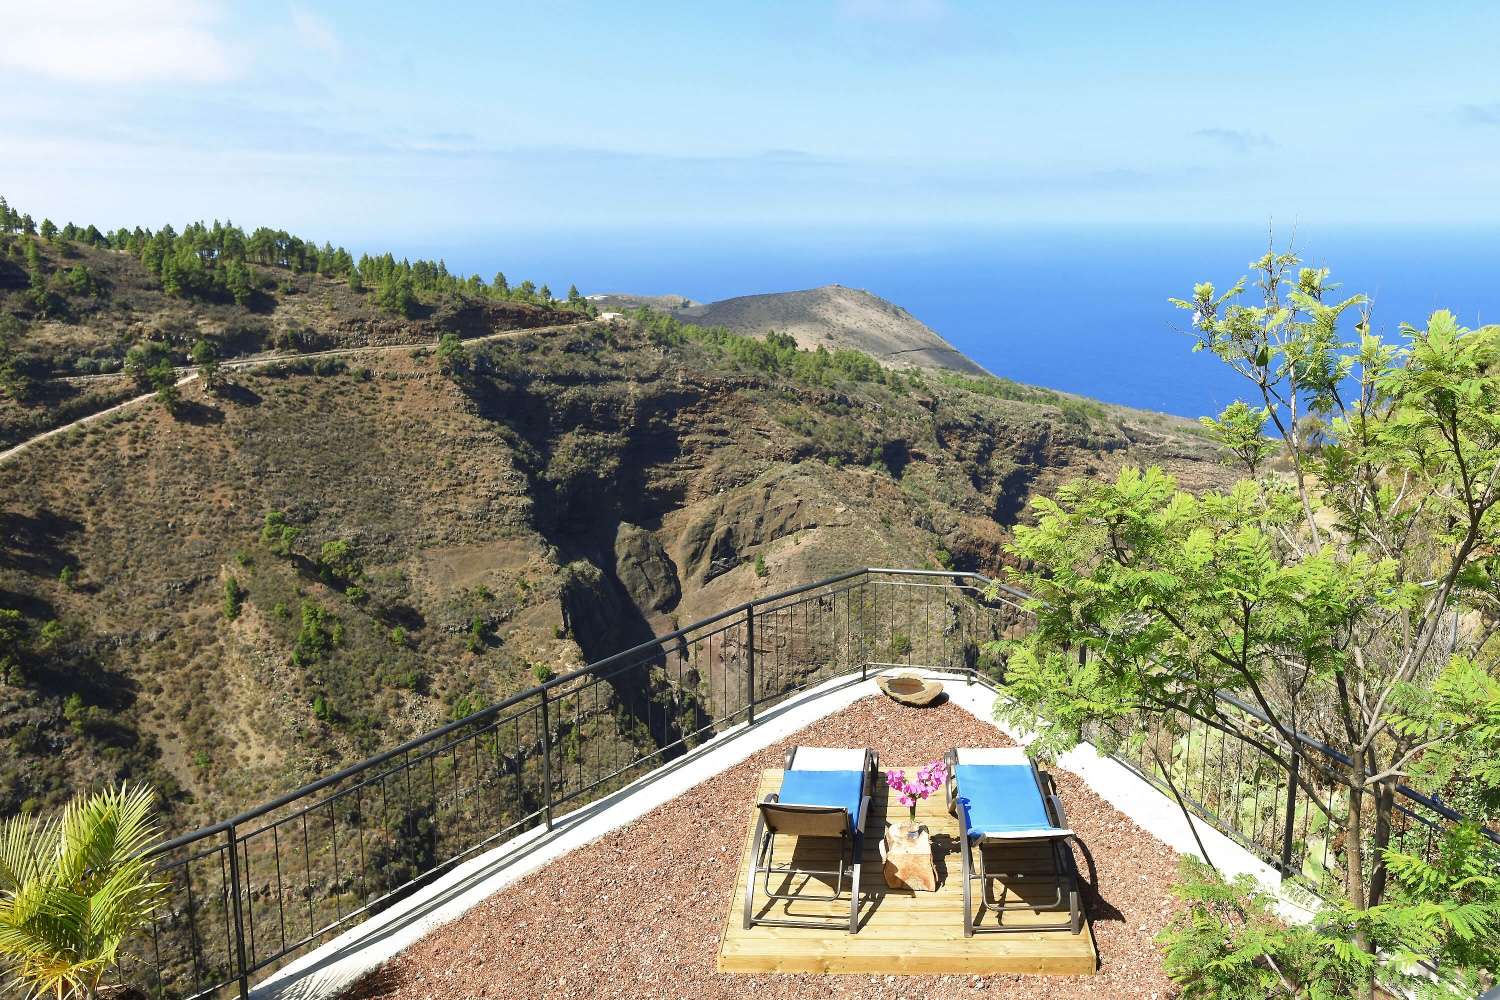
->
<box><xmin>128</xmin><ymin>568</ymin><xmax>1500</xmax><ymax>997</ymax></box>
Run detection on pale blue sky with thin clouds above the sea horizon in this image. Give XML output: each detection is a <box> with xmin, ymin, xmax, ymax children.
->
<box><xmin>0</xmin><ymin>0</ymin><xmax>1500</xmax><ymax>244</ymax></box>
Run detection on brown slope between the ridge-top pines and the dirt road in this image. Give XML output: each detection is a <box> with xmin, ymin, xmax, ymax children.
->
<box><xmin>0</xmin><ymin>234</ymin><xmax>579</xmax><ymax>451</ymax></box>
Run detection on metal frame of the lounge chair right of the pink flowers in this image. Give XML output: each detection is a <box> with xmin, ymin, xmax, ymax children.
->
<box><xmin>944</xmin><ymin>748</ymin><xmax>1083</xmax><ymax>937</ymax></box>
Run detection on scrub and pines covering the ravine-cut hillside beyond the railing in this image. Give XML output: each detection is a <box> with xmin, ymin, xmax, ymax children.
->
<box><xmin>0</xmin><ymin>199</ymin><xmax>1220</xmax><ymax>831</ymax></box>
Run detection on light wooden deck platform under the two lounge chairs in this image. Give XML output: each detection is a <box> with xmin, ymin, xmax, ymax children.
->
<box><xmin>719</xmin><ymin>763</ymin><xmax>1098</xmax><ymax>976</ymax></box>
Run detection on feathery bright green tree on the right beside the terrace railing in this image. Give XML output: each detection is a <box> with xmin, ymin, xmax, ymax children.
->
<box><xmin>1002</xmin><ymin>245</ymin><xmax>1500</xmax><ymax>997</ymax></box>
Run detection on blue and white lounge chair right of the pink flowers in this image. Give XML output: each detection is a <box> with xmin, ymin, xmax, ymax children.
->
<box><xmin>945</xmin><ymin>747</ymin><xmax>1083</xmax><ymax>937</ymax></box>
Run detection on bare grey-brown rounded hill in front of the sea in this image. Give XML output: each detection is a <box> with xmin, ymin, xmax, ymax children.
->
<box><xmin>590</xmin><ymin>285</ymin><xmax>986</xmax><ymax>375</ymax></box>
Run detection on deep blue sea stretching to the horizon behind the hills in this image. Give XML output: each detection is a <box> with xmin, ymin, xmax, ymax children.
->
<box><xmin>390</xmin><ymin>225</ymin><xmax>1500</xmax><ymax>417</ymax></box>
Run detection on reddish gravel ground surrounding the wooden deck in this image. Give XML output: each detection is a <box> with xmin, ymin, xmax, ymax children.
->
<box><xmin>345</xmin><ymin>696</ymin><xmax>1181</xmax><ymax>1000</ymax></box>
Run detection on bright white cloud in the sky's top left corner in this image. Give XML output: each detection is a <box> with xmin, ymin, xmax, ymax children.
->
<box><xmin>0</xmin><ymin>0</ymin><xmax>245</xmax><ymax>84</ymax></box>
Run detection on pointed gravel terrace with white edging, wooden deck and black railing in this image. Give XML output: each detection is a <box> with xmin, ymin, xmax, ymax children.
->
<box><xmin>134</xmin><ymin>570</ymin><xmax>1488</xmax><ymax>1000</ymax></box>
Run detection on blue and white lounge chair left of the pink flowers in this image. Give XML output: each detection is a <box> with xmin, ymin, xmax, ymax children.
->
<box><xmin>744</xmin><ymin>747</ymin><xmax>881</xmax><ymax>934</ymax></box>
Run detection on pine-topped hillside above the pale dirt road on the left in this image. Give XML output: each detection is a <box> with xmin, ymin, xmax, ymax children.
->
<box><xmin>0</xmin><ymin>198</ymin><xmax>593</xmax><ymax>447</ymax></box>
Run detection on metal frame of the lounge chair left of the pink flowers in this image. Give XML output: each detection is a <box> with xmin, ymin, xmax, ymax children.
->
<box><xmin>744</xmin><ymin>747</ymin><xmax>881</xmax><ymax>934</ymax></box>
